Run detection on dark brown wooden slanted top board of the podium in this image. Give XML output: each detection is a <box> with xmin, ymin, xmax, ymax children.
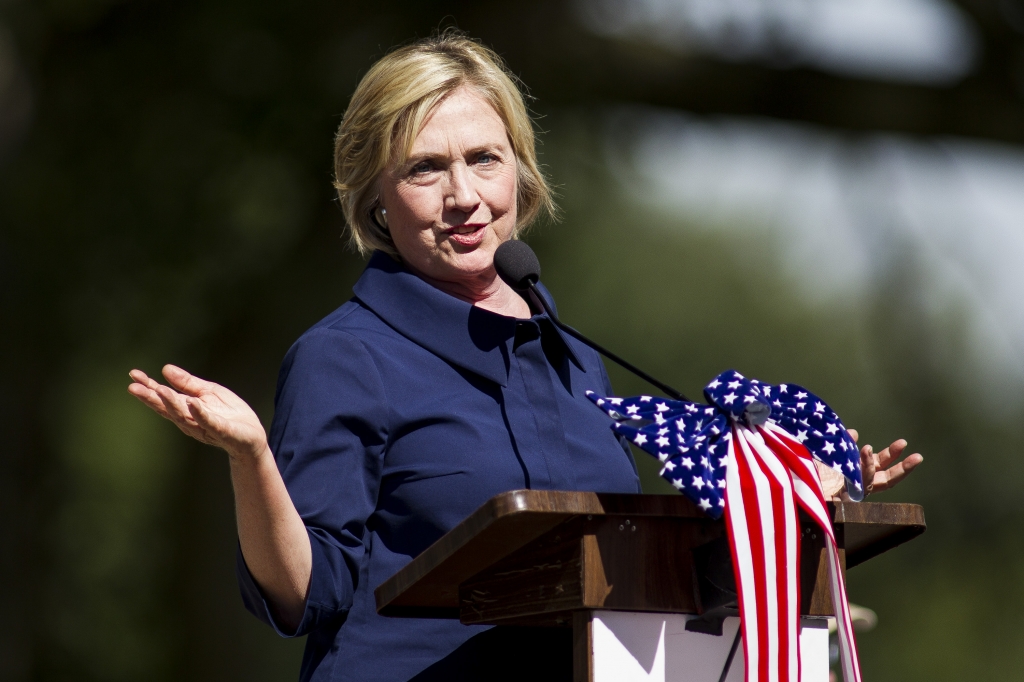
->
<box><xmin>375</xmin><ymin>491</ymin><xmax>925</xmax><ymax>616</ymax></box>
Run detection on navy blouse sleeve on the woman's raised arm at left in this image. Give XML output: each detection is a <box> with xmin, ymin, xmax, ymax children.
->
<box><xmin>238</xmin><ymin>328</ymin><xmax>388</xmax><ymax>637</ymax></box>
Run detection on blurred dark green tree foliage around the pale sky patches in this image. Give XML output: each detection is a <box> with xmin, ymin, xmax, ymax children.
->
<box><xmin>0</xmin><ymin>0</ymin><xmax>1024</xmax><ymax>682</ymax></box>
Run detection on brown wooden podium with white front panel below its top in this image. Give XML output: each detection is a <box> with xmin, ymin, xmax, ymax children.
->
<box><xmin>375</xmin><ymin>491</ymin><xmax>925</xmax><ymax>682</ymax></box>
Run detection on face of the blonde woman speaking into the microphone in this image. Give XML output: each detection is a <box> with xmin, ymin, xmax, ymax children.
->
<box><xmin>381</xmin><ymin>87</ymin><xmax>516</xmax><ymax>289</ymax></box>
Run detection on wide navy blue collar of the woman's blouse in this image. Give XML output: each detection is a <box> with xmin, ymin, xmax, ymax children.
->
<box><xmin>352</xmin><ymin>251</ymin><xmax>583</xmax><ymax>386</ymax></box>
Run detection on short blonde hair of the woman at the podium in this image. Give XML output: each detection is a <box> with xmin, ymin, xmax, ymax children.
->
<box><xmin>334</xmin><ymin>31</ymin><xmax>555</xmax><ymax>257</ymax></box>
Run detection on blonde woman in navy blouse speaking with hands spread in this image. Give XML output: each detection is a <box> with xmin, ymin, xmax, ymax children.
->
<box><xmin>129</xmin><ymin>34</ymin><xmax>921</xmax><ymax>681</ymax></box>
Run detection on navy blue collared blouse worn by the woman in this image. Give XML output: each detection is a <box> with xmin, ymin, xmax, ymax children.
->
<box><xmin>238</xmin><ymin>252</ymin><xmax>640</xmax><ymax>682</ymax></box>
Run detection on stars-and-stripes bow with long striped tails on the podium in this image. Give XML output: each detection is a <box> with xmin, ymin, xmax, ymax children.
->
<box><xmin>588</xmin><ymin>370</ymin><xmax>863</xmax><ymax>682</ymax></box>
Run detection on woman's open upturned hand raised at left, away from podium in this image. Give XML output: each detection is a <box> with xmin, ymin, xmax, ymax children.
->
<box><xmin>128</xmin><ymin>365</ymin><xmax>269</xmax><ymax>458</ymax></box>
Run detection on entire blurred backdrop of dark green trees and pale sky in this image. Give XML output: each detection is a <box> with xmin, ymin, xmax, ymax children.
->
<box><xmin>0</xmin><ymin>0</ymin><xmax>1024</xmax><ymax>682</ymax></box>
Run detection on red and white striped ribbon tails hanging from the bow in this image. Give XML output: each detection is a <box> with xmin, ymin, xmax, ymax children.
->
<box><xmin>725</xmin><ymin>421</ymin><xmax>860</xmax><ymax>682</ymax></box>
